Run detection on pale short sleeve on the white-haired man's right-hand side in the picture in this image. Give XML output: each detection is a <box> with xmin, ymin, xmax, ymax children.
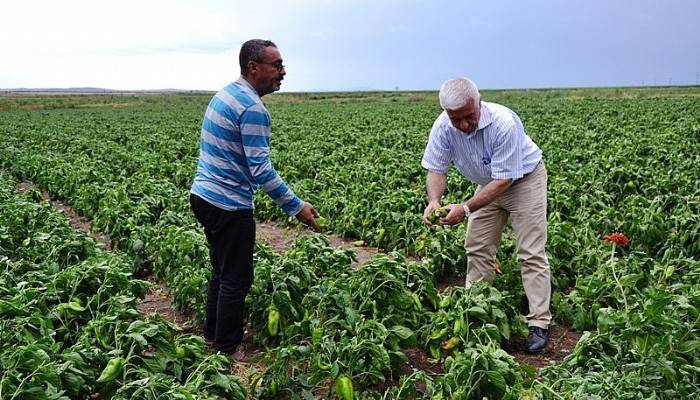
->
<box><xmin>491</xmin><ymin>117</ymin><xmax>525</xmax><ymax>180</ymax></box>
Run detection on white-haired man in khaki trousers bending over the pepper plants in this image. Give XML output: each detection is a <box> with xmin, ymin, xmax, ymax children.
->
<box><xmin>422</xmin><ymin>78</ymin><xmax>551</xmax><ymax>352</ymax></box>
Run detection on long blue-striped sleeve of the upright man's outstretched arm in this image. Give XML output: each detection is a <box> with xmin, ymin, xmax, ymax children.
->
<box><xmin>240</xmin><ymin>104</ymin><xmax>304</xmax><ymax>215</ymax></box>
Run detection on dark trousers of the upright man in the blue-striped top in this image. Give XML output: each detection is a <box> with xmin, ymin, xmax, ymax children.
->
<box><xmin>190</xmin><ymin>194</ymin><xmax>255</xmax><ymax>353</ymax></box>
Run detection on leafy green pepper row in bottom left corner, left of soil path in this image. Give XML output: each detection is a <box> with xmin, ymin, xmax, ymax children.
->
<box><xmin>0</xmin><ymin>172</ymin><xmax>246</xmax><ymax>399</ymax></box>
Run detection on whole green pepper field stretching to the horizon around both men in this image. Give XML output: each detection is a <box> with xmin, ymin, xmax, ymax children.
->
<box><xmin>0</xmin><ymin>87</ymin><xmax>700</xmax><ymax>399</ymax></box>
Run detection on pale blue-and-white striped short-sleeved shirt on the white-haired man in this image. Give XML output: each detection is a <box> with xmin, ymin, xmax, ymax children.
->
<box><xmin>421</xmin><ymin>101</ymin><xmax>542</xmax><ymax>186</ymax></box>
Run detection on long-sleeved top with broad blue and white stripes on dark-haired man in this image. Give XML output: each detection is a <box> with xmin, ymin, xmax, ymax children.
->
<box><xmin>191</xmin><ymin>78</ymin><xmax>304</xmax><ymax>215</ymax></box>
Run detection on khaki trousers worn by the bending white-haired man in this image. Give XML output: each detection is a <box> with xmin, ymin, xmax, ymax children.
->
<box><xmin>464</xmin><ymin>163</ymin><xmax>552</xmax><ymax>329</ymax></box>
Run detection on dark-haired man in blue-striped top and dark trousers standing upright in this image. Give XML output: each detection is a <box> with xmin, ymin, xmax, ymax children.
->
<box><xmin>190</xmin><ymin>39</ymin><xmax>318</xmax><ymax>354</ymax></box>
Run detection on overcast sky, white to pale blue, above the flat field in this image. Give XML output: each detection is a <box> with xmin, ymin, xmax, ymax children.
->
<box><xmin>0</xmin><ymin>0</ymin><xmax>700</xmax><ymax>91</ymax></box>
